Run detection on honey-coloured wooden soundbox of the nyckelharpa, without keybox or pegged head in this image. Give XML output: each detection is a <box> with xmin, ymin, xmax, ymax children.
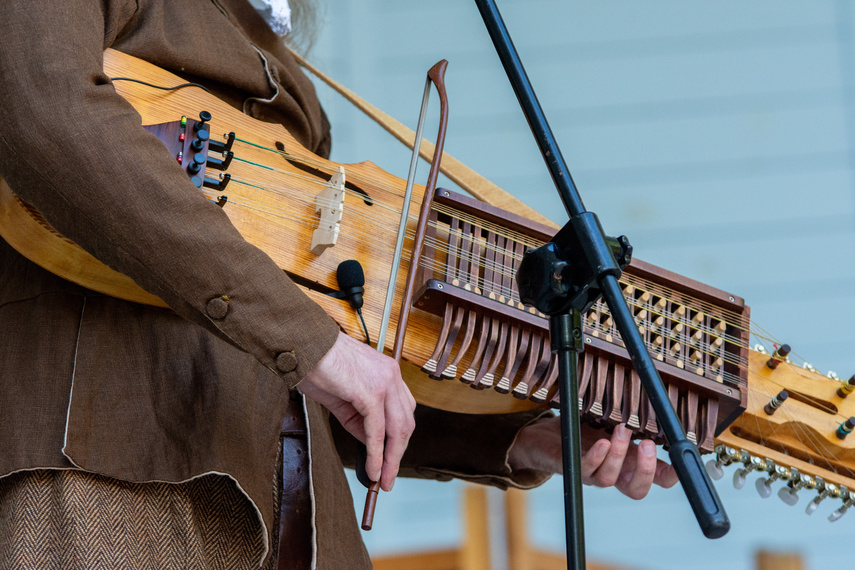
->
<box><xmin>0</xmin><ymin>50</ymin><xmax>535</xmax><ymax>413</ymax></box>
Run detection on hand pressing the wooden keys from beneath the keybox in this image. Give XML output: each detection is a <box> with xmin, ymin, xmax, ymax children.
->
<box><xmin>508</xmin><ymin>418</ymin><xmax>677</xmax><ymax>499</ymax></box>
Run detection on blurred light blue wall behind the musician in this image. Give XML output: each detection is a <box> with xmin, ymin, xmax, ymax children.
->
<box><xmin>310</xmin><ymin>0</ymin><xmax>855</xmax><ymax>570</ymax></box>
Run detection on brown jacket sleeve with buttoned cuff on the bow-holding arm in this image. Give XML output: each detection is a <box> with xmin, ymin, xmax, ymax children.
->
<box><xmin>0</xmin><ymin>0</ymin><xmax>338</xmax><ymax>387</ymax></box>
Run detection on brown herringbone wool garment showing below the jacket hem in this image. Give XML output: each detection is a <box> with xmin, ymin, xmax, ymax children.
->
<box><xmin>0</xmin><ymin>470</ymin><xmax>269</xmax><ymax>570</ymax></box>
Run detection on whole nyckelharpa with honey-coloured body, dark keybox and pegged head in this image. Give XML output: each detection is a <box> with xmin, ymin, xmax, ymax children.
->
<box><xmin>5</xmin><ymin>50</ymin><xmax>855</xmax><ymax>510</ymax></box>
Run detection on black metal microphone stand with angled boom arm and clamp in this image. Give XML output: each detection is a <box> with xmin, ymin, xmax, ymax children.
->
<box><xmin>475</xmin><ymin>0</ymin><xmax>730</xmax><ymax>570</ymax></box>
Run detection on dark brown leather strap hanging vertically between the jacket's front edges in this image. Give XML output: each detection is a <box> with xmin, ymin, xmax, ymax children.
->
<box><xmin>276</xmin><ymin>392</ymin><xmax>313</xmax><ymax>570</ymax></box>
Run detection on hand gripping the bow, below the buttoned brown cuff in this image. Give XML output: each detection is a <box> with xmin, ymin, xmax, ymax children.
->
<box><xmin>298</xmin><ymin>333</ymin><xmax>416</xmax><ymax>491</ymax></box>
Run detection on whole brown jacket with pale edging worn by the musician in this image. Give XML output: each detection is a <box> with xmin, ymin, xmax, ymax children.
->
<box><xmin>0</xmin><ymin>0</ymin><xmax>546</xmax><ymax>568</ymax></box>
